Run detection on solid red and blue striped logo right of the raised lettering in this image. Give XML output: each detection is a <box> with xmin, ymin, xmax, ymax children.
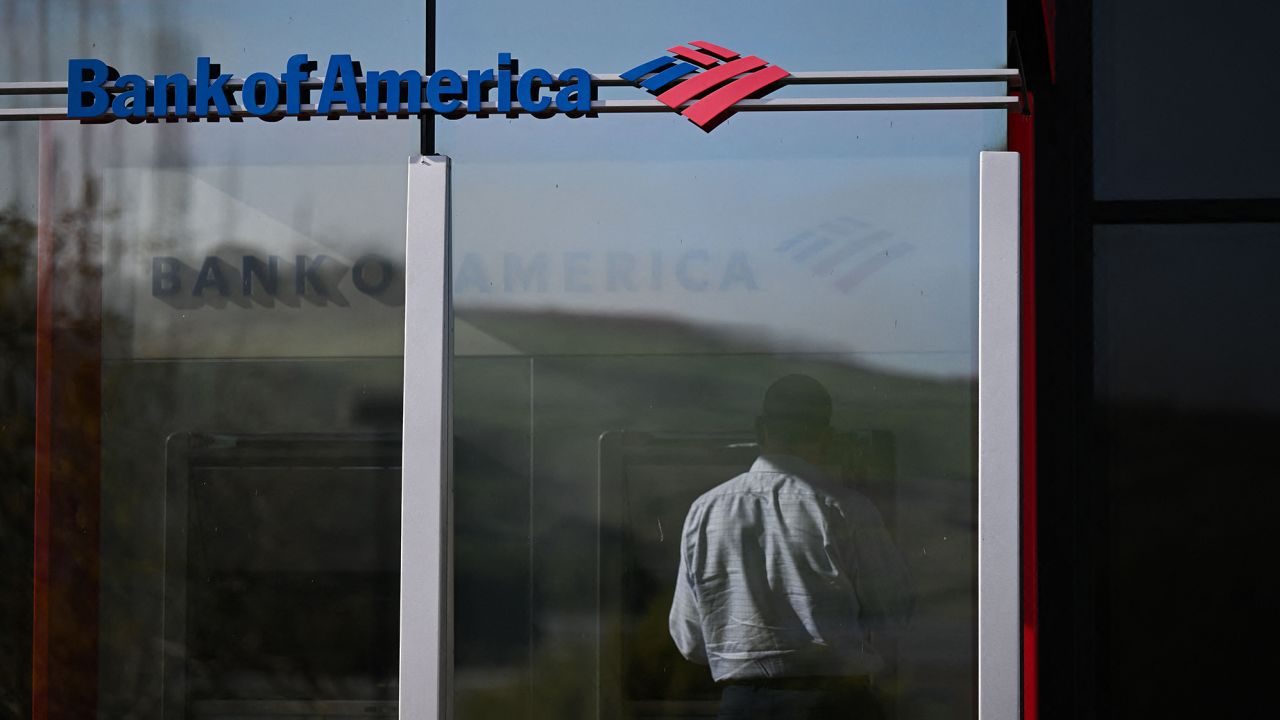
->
<box><xmin>622</xmin><ymin>40</ymin><xmax>791</xmax><ymax>132</ymax></box>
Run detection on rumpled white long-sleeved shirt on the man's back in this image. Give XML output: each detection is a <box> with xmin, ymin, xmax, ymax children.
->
<box><xmin>669</xmin><ymin>455</ymin><xmax>913</xmax><ymax>680</ymax></box>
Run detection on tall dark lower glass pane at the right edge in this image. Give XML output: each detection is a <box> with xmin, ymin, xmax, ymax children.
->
<box><xmin>1093</xmin><ymin>224</ymin><xmax>1280</xmax><ymax>717</ymax></box>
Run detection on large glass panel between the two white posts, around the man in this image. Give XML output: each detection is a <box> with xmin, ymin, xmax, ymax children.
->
<box><xmin>436</xmin><ymin>3</ymin><xmax>1005</xmax><ymax>720</ymax></box>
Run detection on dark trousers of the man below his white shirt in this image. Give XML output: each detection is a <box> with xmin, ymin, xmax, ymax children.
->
<box><xmin>718</xmin><ymin>683</ymin><xmax>884</xmax><ymax>720</ymax></box>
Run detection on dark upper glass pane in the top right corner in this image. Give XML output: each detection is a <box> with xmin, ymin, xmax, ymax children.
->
<box><xmin>1092</xmin><ymin>0</ymin><xmax>1280</xmax><ymax>200</ymax></box>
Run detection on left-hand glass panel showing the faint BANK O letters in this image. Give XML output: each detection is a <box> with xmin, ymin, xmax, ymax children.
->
<box><xmin>0</xmin><ymin>0</ymin><xmax>425</xmax><ymax>720</ymax></box>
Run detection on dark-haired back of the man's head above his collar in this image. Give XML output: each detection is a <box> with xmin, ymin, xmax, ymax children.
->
<box><xmin>755</xmin><ymin>375</ymin><xmax>831</xmax><ymax>460</ymax></box>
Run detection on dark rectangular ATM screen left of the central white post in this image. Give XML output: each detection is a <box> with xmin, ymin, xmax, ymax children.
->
<box><xmin>165</xmin><ymin>436</ymin><xmax>401</xmax><ymax>719</ymax></box>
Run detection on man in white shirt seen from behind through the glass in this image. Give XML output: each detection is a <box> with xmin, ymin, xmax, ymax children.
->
<box><xmin>671</xmin><ymin>375</ymin><xmax>911</xmax><ymax>720</ymax></box>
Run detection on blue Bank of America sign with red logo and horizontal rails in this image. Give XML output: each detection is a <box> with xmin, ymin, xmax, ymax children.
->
<box><xmin>0</xmin><ymin>40</ymin><xmax>1021</xmax><ymax>124</ymax></box>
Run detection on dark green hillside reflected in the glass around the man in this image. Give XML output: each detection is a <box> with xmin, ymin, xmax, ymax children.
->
<box><xmin>454</xmin><ymin>345</ymin><xmax>974</xmax><ymax>717</ymax></box>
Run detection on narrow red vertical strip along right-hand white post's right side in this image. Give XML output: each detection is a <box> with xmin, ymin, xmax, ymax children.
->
<box><xmin>1009</xmin><ymin>94</ymin><xmax>1039</xmax><ymax>720</ymax></box>
